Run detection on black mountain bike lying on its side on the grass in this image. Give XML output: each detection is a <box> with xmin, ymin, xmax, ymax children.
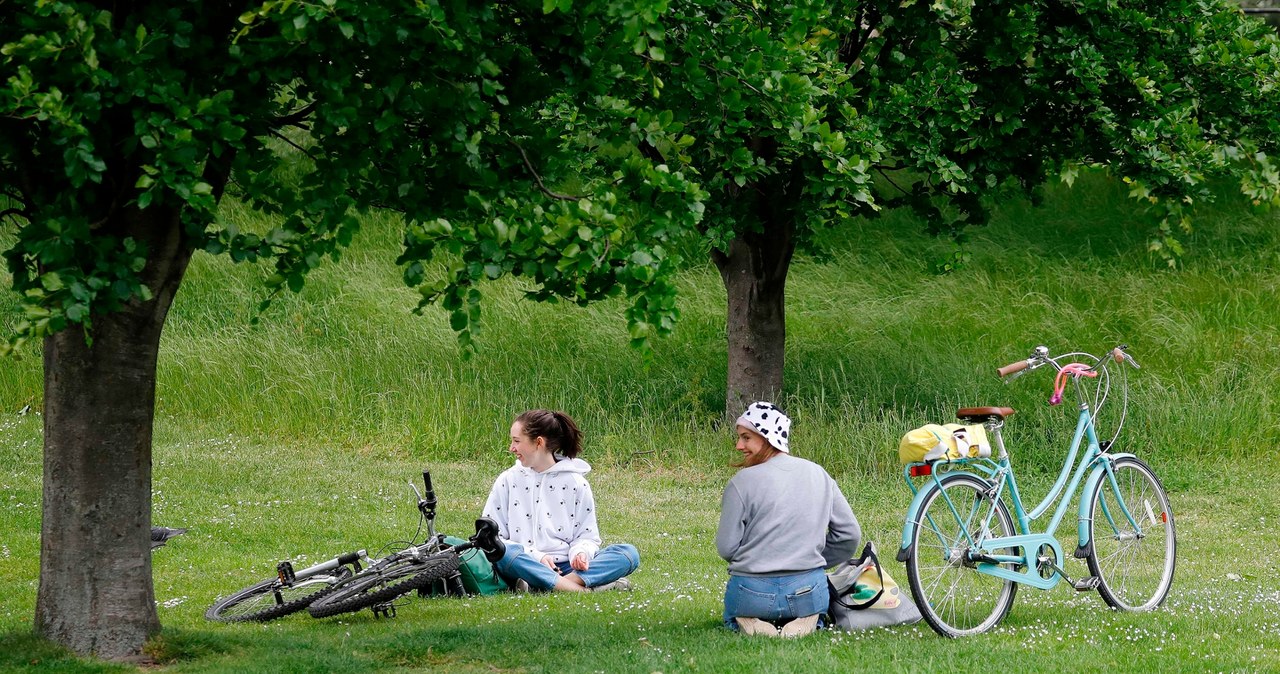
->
<box><xmin>205</xmin><ymin>471</ymin><xmax>504</xmax><ymax>623</ymax></box>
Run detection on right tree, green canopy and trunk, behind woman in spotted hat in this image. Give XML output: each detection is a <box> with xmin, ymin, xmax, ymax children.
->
<box><xmin>586</xmin><ymin>0</ymin><xmax>1280</xmax><ymax>414</ymax></box>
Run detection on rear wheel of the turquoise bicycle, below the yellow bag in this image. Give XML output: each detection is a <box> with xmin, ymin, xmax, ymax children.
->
<box><xmin>906</xmin><ymin>473</ymin><xmax>1018</xmax><ymax>638</ymax></box>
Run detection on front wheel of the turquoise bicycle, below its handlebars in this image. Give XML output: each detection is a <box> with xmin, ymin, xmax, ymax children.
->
<box><xmin>1088</xmin><ymin>457</ymin><xmax>1178</xmax><ymax>611</ymax></box>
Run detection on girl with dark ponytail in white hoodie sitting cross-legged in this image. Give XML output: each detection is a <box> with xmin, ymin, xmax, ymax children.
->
<box><xmin>484</xmin><ymin>409</ymin><xmax>640</xmax><ymax>592</ymax></box>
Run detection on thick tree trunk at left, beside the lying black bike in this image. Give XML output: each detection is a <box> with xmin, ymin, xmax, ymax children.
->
<box><xmin>35</xmin><ymin>208</ymin><xmax>191</xmax><ymax>659</ymax></box>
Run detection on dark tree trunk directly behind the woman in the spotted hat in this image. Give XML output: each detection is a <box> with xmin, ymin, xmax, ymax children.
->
<box><xmin>712</xmin><ymin>211</ymin><xmax>795</xmax><ymax>419</ymax></box>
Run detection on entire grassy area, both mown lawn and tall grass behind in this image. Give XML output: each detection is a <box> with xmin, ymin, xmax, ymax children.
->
<box><xmin>0</xmin><ymin>178</ymin><xmax>1280</xmax><ymax>673</ymax></box>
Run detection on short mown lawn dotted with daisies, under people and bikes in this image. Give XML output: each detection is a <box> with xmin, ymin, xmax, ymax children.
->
<box><xmin>0</xmin><ymin>421</ymin><xmax>1280</xmax><ymax>673</ymax></box>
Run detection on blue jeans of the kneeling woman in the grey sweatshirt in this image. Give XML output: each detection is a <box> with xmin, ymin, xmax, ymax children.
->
<box><xmin>724</xmin><ymin>569</ymin><xmax>831</xmax><ymax>631</ymax></box>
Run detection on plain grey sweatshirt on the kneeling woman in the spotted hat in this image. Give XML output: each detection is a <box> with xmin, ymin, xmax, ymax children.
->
<box><xmin>716</xmin><ymin>454</ymin><xmax>863</xmax><ymax>576</ymax></box>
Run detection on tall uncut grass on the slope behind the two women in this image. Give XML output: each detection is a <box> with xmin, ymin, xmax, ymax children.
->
<box><xmin>0</xmin><ymin>171</ymin><xmax>1280</xmax><ymax>474</ymax></box>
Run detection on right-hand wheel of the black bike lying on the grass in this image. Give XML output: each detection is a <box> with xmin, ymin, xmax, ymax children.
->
<box><xmin>307</xmin><ymin>553</ymin><xmax>458</xmax><ymax>618</ymax></box>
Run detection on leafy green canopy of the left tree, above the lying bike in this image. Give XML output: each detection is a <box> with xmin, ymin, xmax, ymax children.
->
<box><xmin>0</xmin><ymin>0</ymin><xmax>699</xmax><ymax>358</ymax></box>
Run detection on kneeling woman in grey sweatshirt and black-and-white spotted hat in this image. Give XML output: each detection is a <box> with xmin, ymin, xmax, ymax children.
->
<box><xmin>716</xmin><ymin>403</ymin><xmax>861</xmax><ymax>637</ymax></box>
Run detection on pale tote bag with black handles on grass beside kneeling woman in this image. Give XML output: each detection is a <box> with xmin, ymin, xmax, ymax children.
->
<box><xmin>827</xmin><ymin>542</ymin><xmax>920</xmax><ymax>629</ymax></box>
